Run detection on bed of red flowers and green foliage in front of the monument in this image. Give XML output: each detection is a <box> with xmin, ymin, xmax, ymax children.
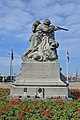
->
<box><xmin>0</xmin><ymin>89</ymin><xmax>80</xmax><ymax>120</ymax></box>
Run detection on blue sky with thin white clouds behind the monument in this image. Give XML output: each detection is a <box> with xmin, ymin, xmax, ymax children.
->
<box><xmin>0</xmin><ymin>0</ymin><xmax>80</xmax><ymax>75</ymax></box>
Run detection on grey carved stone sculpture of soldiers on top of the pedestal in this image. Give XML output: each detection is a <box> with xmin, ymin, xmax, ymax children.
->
<box><xmin>22</xmin><ymin>19</ymin><xmax>62</xmax><ymax>61</ymax></box>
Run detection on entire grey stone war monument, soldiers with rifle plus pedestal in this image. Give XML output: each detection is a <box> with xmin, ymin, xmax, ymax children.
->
<box><xmin>10</xmin><ymin>19</ymin><xmax>68</xmax><ymax>98</ymax></box>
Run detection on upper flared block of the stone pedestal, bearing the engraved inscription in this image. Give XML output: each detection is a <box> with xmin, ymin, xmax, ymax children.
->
<box><xmin>13</xmin><ymin>61</ymin><xmax>67</xmax><ymax>85</ymax></box>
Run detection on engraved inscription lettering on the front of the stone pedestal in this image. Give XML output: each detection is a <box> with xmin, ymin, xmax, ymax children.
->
<box><xmin>22</xmin><ymin>63</ymin><xmax>59</xmax><ymax>78</ymax></box>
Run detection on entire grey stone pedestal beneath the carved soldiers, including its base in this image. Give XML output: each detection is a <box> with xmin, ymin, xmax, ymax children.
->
<box><xmin>10</xmin><ymin>60</ymin><xmax>68</xmax><ymax>98</ymax></box>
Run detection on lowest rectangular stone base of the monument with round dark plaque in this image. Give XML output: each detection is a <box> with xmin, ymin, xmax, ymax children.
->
<box><xmin>11</xmin><ymin>86</ymin><xmax>68</xmax><ymax>98</ymax></box>
